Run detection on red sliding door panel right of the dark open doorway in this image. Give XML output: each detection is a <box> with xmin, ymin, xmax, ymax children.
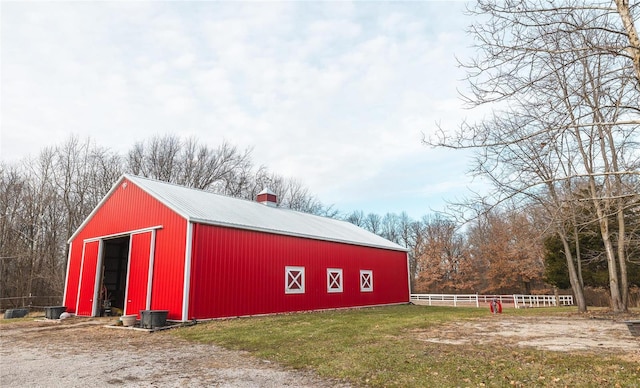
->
<box><xmin>124</xmin><ymin>232</ymin><xmax>151</xmax><ymax>317</ymax></box>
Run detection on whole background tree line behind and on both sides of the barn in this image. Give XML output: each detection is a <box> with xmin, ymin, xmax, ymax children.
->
<box><xmin>0</xmin><ymin>136</ymin><xmax>640</xmax><ymax>310</ymax></box>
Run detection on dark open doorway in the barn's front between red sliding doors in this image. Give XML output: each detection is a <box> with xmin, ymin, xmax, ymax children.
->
<box><xmin>99</xmin><ymin>236</ymin><xmax>130</xmax><ymax>316</ymax></box>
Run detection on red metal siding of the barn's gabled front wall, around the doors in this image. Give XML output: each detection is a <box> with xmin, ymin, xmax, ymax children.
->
<box><xmin>65</xmin><ymin>179</ymin><xmax>187</xmax><ymax>319</ymax></box>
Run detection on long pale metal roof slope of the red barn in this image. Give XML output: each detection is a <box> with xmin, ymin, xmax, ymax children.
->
<box><xmin>124</xmin><ymin>174</ymin><xmax>407</xmax><ymax>251</ymax></box>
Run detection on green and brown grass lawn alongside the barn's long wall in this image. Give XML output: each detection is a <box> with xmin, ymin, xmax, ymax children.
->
<box><xmin>175</xmin><ymin>305</ymin><xmax>640</xmax><ymax>387</ymax></box>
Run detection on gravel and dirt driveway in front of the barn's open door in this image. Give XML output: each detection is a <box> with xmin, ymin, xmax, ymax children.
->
<box><xmin>0</xmin><ymin>318</ymin><xmax>340</xmax><ymax>388</ymax></box>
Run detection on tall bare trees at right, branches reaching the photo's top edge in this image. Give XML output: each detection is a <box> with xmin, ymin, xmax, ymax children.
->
<box><xmin>430</xmin><ymin>0</ymin><xmax>640</xmax><ymax>311</ymax></box>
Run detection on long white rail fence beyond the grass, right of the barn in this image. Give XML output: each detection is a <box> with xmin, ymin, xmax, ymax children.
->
<box><xmin>411</xmin><ymin>294</ymin><xmax>573</xmax><ymax>309</ymax></box>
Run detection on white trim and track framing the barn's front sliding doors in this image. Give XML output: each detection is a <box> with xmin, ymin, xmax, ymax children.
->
<box><xmin>76</xmin><ymin>225</ymin><xmax>162</xmax><ymax>317</ymax></box>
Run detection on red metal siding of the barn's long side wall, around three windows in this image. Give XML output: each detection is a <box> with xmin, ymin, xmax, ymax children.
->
<box><xmin>189</xmin><ymin>225</ymin><xmax>409</xmax><ymax>319</ymax></box>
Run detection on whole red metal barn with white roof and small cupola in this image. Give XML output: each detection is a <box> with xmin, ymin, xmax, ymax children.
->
<box><xmin>64</xmin><ymin>175</ymin><xmax>409</xmax><ymax>321</ymax></box>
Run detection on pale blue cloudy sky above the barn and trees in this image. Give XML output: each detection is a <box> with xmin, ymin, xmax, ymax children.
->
<box><xmin>0</xmin><ymin>1</ymin><xmax>478</xmax><ymax>218</ymax></box>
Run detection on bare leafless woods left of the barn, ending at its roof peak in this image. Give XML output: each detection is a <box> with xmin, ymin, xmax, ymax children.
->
<box><xmin>0</xmin><ymin>136</ymin><xmax>122</xmax><ymax>304</ymax></box>
